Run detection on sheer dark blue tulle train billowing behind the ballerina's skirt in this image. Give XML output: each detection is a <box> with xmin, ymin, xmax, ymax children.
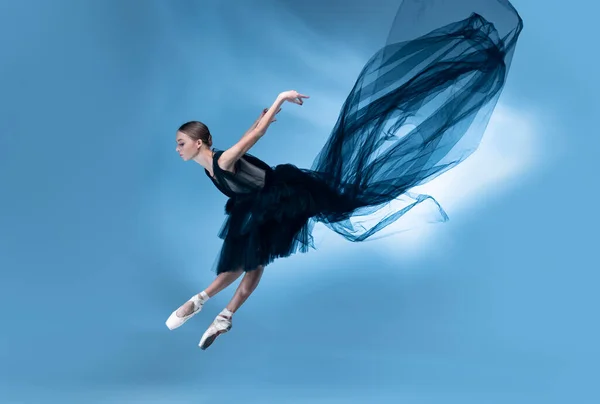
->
<box><xmin>311</xmin><ymin>0</ymin><xmax>523</xmax><ymax>241</ymax></box>
